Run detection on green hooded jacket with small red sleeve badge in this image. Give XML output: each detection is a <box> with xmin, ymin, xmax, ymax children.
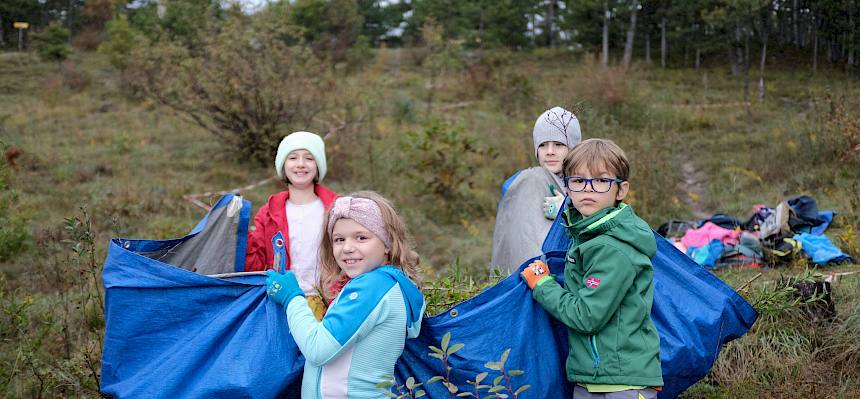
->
<box><xmin>533</xmin><ymin>203</ymin><xmax>663</xmax><ymax>386</ymax></box>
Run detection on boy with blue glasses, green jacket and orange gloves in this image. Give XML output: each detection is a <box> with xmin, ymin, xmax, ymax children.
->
<box><xmin>521</xmin><ymin>139</ymin><xmax>663</xmax><ymax>399</ymax></box>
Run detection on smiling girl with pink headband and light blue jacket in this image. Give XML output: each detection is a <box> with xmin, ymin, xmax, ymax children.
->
<box><xmin>266</xmin><ymin>191</ymin><xmax>426</xmax><ymax>399</ymax></box>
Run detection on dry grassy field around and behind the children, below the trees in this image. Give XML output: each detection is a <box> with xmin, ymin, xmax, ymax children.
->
<box><xmin>0</xmin><ymin>50</ymin><xmax>860</xmax><ymax>398</ymax></box>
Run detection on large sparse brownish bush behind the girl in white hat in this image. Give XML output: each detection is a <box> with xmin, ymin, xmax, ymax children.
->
<box><xmin>128</xmin><ymin>18</ymin><xmax>340</xmax><ymax>165</ymax></box>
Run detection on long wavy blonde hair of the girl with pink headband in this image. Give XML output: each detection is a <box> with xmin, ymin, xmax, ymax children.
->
<box><xmin>319</xmin><ymin>191</ymin><xmax>420</xmax><ymax>300</ymax></box>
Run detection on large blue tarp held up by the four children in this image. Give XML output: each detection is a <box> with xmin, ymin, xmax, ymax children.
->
<box><xmin>101</xmin><ymin>196</ymin><xmax>756</xmax><ymax>398</ymax></box>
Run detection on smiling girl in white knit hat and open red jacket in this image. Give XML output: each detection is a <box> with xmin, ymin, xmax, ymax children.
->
<box><xmin>245</xmin><ymin>132</ymin><xmax>337</xmax><ymax>318</ymax></box>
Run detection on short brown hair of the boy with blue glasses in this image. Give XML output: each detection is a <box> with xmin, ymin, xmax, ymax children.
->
<box><xmin>563</xmin><ymin>139</ymin><xmax>630</xmax><ymax>180</ymax></box>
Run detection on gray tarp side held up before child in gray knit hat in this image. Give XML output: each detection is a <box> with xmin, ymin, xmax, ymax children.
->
<box><xmin>491</xmin><ymin>166</ymin><xmax>563</xmax><ymax>274</ymax></box>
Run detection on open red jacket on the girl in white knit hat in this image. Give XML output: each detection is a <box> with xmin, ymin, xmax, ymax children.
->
<box><xmin>245</xmin><ymin>184</ymin><xmax>337</xmax><ymax>272</ymax></box>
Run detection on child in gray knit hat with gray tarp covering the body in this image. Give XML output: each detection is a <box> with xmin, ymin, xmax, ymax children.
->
<box><xmin>491</xmin><ymin>107</ymin><xmax>582</xmax><ymax>273</ymax></box>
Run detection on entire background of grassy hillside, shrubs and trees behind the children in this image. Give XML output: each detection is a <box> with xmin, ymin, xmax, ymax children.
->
<box><xmin>0</xmin><ymin>0</ymin><xmax>860</xmax><ymax>398</ymax></box>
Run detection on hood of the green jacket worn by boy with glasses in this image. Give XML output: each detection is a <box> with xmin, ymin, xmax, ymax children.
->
<box><xmin>565</xmin><ymin>202</ymin><xmax>657</xmax><ymax>258</ymax></box>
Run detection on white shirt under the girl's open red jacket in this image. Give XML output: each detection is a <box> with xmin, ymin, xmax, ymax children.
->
<box><xmin>287</xmin><ymin>199</ymin><xmax>325</xmax><ymax>295</ymax></box>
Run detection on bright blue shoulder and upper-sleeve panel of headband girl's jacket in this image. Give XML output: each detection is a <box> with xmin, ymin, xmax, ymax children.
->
<box><xmin>322</xmin><ymin>268</ymin><xmax>396</xmax><ymax>345</ymax></box>
